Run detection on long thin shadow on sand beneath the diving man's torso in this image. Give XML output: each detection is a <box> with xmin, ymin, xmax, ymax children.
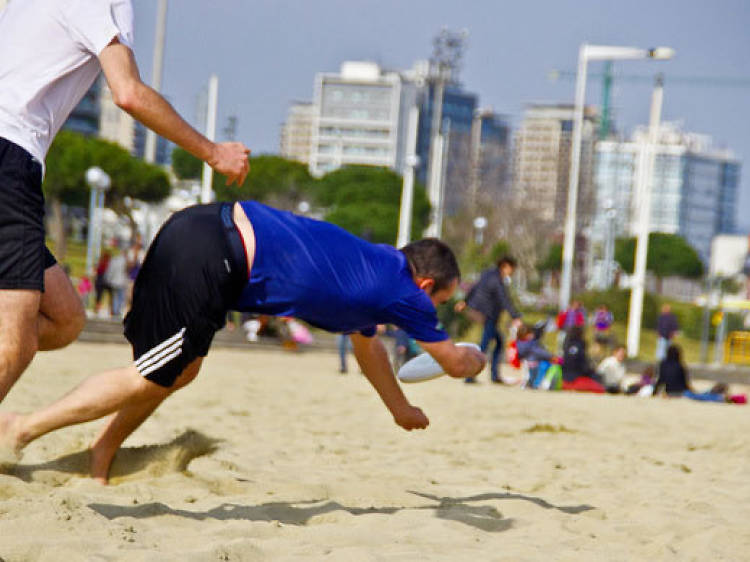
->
<box><xmin>88</xmin><ymin>491</ymin><xmax>594</xmax><ymax>533</ymax></box>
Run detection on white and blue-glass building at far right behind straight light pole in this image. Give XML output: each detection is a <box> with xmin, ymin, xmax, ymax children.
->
<box><xmin>592</xmin><ymin>123</ymin><xmax>740</xmax><ymax>263</ymax></box>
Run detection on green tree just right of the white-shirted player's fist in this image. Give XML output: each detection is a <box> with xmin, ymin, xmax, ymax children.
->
<box><xmin>213</xmin><ymin>155</ymin><xmax>315</xmax><ymax>210</ymax></box>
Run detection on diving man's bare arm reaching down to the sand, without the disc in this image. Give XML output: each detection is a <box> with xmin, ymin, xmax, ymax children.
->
<box><xmin>351</xmin><ymin>334</ymin><xmax>430</xmax><ymax>431</ymax></box>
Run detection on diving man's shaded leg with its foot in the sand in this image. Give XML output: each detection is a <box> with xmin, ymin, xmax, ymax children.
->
<box><xmin>91</xmin><ymin>357</ymin><xmax>203</xmax><ymax>484</ymax></box>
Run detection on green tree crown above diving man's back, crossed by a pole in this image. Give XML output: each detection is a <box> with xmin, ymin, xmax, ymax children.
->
<box><xmin>314</xmin><ymin>166</ymin><xmax>430</xmax><ymax>244</ymax></box>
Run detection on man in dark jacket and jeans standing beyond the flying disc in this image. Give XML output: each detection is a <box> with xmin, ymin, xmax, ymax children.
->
<box><xmin>457</xmin><ymin>256</ymin><xmax>521</xmax><ymax>384</ymax></box>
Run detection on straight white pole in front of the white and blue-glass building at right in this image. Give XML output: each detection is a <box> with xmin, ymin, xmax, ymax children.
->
<box><xmin>628</xmin><ymin>74</ymin><xmax>664</xmax><ymax>357</ymax></box>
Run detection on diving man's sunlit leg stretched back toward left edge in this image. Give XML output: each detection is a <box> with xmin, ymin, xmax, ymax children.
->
<box><xmin>0</xmin><ymin>365</ymin><xmax>171</xmax><ymax>451</ymax></box>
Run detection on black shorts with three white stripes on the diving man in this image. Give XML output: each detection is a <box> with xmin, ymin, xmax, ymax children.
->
<box><xmin>125</xmin><ymin>203</ymin><xmax>247</xmax><ymax>387</ymax></box>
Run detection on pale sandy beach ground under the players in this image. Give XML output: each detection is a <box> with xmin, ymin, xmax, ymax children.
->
<box><xmin>0</xmin><ymin>343</ymin><xmax>750</xmax><ymax>562</ymax></box>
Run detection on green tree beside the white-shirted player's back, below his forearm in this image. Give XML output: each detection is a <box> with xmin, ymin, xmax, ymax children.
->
<box><xmin>42</xmin><ymin>131</ymin><xmax>170</xmax><ymax>259</ymax></box>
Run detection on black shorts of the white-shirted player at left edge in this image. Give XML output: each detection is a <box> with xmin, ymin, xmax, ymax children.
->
<box><xmin>0</xmin><ymin>138</ymin><xmax>56</xmax><ymax>291</ymax></box>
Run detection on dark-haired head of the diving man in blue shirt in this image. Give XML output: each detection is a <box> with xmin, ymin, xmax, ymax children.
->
<box><xmin>401</xmin><ymin>238</ymin><xmax>461</xmax><ymax>305</ymax></box>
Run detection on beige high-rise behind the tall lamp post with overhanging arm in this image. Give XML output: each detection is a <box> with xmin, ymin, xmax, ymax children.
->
<box><xmin>513</xmin><ymin>104</ymin><xmax>598</xmax><ymax>223</ymax></box>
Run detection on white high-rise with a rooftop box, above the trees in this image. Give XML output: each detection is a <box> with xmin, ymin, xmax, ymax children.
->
<box><xmin>310</xmin><ymin>61</ymin><xmax>418</xmax><ymax>176</ymax></box>
